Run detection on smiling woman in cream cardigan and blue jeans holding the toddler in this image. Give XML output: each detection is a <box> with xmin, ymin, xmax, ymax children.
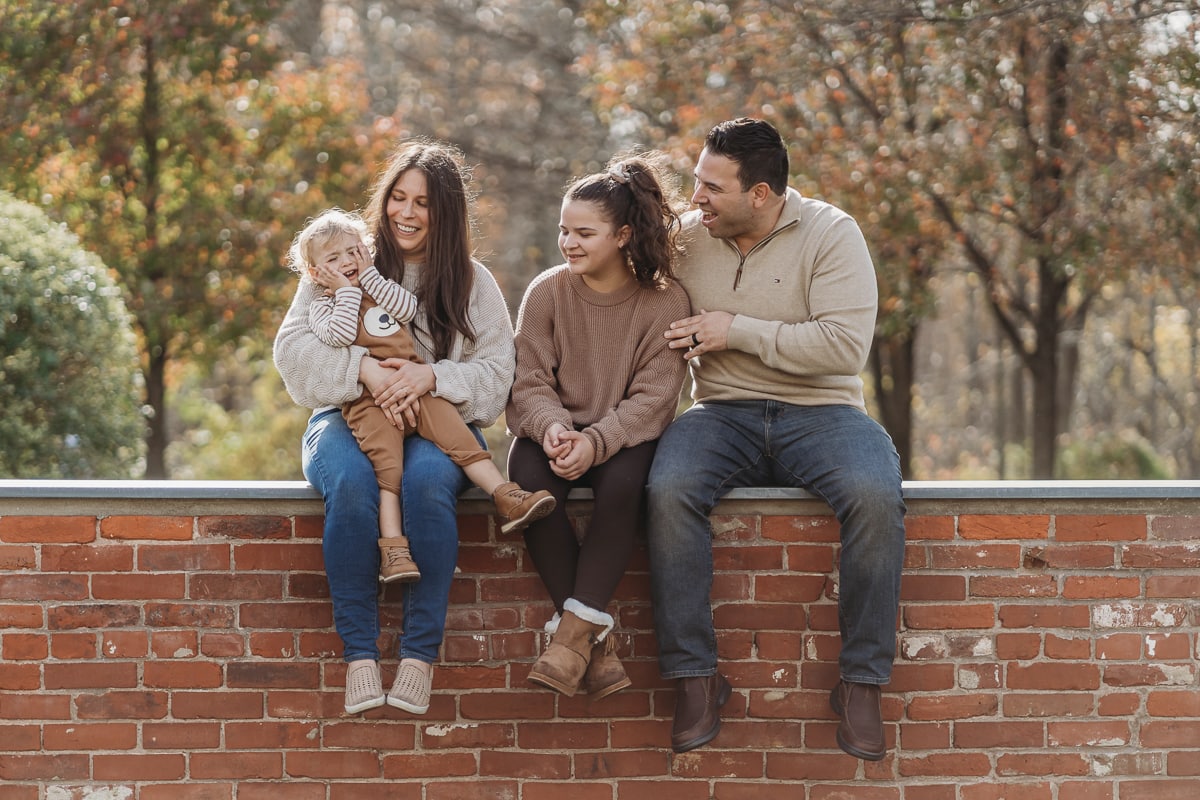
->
<box><xmin>275</xmin><ymin>140</ymin><xmax>514</xmax><ymax>714</ymax></box>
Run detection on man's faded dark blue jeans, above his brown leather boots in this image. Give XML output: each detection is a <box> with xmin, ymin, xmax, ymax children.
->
<box><xmin>648</xmin><ymin>401</ymin><xmax>905</xmax><ymax>685</ymax></box>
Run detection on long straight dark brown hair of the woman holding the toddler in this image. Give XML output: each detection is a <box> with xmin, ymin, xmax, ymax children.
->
<box><xmin>366</xmin><ymin>139</ymin><xmax>475</xmax><ymax>359</ymax></box>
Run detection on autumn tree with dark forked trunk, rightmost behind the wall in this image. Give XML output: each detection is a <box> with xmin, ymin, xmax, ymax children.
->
<box><xmin>809</xmin><ymin>1</ymin><xmax>1195</xmax><ymax>477</ymax></box>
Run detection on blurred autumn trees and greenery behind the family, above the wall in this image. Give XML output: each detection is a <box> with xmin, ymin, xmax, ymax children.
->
<box><xmin>0</xmin><ymin>0</ymin><xmax>1200</xmax><ymax>480</ymax></box>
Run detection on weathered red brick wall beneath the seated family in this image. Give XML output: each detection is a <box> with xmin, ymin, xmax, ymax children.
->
<box><xmin>0</xmin><ymin>482</ymin><xmax>1200</xmax><ymax>800</ymax></box>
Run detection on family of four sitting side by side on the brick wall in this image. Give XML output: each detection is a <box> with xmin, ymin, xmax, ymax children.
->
<box><xmin>275</xmin><ymin>119</ymin><xmax>905</xmax><ymax>760</ymax></box>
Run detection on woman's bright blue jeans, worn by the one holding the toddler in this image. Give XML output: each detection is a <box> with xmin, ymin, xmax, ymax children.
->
<box><xmin>302</xmin><ymin>409</ymin><xmax>477</xmax><ymax>663</ymax></box>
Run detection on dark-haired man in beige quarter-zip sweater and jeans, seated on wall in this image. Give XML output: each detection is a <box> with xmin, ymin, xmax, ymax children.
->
<box><xmin>648</xmin><ymin>119</ymin><xmax>905</xmax><ymax>760</ymax></box>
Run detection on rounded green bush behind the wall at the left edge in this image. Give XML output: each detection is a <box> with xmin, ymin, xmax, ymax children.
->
<box><xmin>0</xmin><ymin>192</ymin><xmax>143</xmax><ymax>479</ymax></box>
